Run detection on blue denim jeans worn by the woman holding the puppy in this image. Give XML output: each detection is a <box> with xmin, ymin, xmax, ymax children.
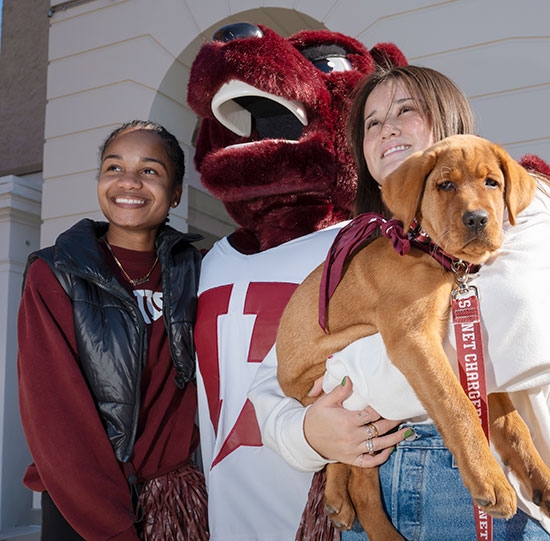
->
<box><xmin>342</xmin><ymin>425</ymin><xmax>550</xmax><ymax>541</ymax></box>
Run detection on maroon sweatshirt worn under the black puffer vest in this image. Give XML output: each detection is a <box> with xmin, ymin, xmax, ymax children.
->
<box><xmin>18</xmin><ymin>247</ymin><xmax>202</xmax><ymax>541</ymax></box>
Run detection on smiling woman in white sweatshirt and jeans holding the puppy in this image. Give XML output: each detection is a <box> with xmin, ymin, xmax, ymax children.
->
<box><xmin>250</xmin><ymin>66</ymin><xmax>550</xmax><ymax>541</ymax></box>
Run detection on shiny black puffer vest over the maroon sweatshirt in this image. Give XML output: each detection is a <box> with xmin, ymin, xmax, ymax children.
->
<box><xmin>27</xmin><ymin>219</ymin><xmax>201</xmax><ymax>462</ymax></box>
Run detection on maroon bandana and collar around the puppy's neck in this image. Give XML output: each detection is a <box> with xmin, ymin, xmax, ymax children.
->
<box><xmin>319</xmin><ymin>212</ymin><xmax>480</xmax><ymax>332</ymax></box>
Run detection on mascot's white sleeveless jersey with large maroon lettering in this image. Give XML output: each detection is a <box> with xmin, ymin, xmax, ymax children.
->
<box><xmin>195</xmin><ymin>224</ymin><xmax>344</xmax><ymax>541</ymax></box>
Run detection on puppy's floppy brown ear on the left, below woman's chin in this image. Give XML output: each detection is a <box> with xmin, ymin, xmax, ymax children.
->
<box><xmin>382</xmin><ymin>150</ymin><xmax>438</xmax><ymax>230</ymax></box>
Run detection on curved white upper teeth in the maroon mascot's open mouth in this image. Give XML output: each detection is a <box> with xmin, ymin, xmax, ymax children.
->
<box><xmin>212</xmin><ymin>79</ymin><xmax>308</xmax><ymax>137</ymax></box>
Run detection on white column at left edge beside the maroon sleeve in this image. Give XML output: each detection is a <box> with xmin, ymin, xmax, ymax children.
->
<box><xmin>0</xmin><ymin>174</ymin><xmax>42</xmax><ymax>540</ymax></box>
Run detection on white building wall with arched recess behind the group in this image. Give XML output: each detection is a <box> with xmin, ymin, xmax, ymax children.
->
<box><xmin>0</xmin><ymin>0</ymin><xmax>550</xmax><ymax>539</ymax></box>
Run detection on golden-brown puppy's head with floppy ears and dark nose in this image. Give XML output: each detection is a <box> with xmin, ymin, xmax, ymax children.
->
<box><xmin>382</xmin><ymin>135</ymin><xmax>535</xmax><ymax>263</ymax></box>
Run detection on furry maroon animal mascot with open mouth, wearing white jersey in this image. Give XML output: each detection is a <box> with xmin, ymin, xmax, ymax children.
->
<box><xmin>188</xmin><ymin>23</ymin><xmax>406</xmax><ymax>540</ymax></box>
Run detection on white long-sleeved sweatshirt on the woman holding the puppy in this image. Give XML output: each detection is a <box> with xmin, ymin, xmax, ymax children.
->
<box><xmin>249</xmin><ymin>187</ymin><xmax>550</xmax><ymax>532</ymax></box>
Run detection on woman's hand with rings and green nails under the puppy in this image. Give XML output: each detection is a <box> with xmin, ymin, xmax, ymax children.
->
<box><xmin>304</xmin><ymin>378</ymin><xmax>410</xmax><ymax>468</ymax></box>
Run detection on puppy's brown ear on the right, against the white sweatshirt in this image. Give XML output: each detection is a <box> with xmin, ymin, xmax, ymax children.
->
<box><xmin>495</xmin><ymin>145</ymin><xmax>536</xmax><ymax>225</ymax></box>
